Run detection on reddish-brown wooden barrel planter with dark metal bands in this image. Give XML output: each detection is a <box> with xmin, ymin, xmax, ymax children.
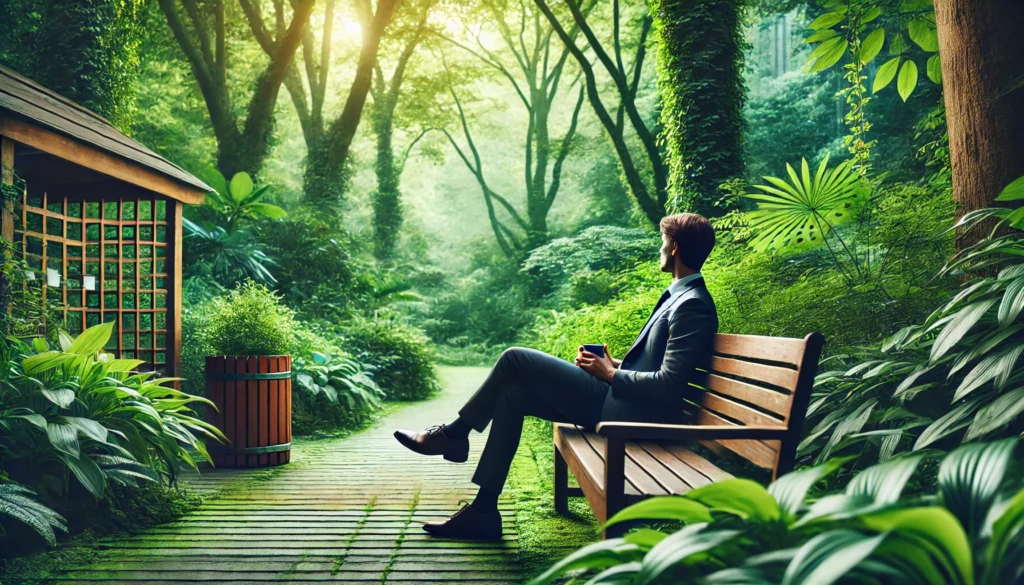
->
<box><xmin>206</xmin><ymin>356</ymin><xmax>292</xmax><ymax>467</ymax></box>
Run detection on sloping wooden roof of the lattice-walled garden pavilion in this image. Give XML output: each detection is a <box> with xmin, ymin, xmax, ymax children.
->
<box><xmin>0</xmin><ymin>67</ymin><xmax>213</xmax><ymax>203</ymax></box>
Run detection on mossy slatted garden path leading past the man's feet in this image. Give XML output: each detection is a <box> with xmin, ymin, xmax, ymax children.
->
<box><xmin>57</xmin><ymin>368</ymin><xmax>522</xmax><ymax>585</ymax></box>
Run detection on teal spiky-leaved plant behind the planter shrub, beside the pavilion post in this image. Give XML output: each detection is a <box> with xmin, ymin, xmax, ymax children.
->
<box><xmin>181</xmin><ymin>217</ymin><xmax>276</xmax><ymax>284</ymax></box>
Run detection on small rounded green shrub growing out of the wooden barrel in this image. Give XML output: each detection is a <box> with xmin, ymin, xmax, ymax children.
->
<box><xmin>206</xmin><ymin>281</ymin><xmax>297</xmax><ymax>356</ymax></box>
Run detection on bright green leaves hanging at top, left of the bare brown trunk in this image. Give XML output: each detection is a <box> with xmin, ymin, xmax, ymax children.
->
<box><xmin>805</xmin><ymin>0</ymin><xmax>942</xmax><ymax>101</ymax></box>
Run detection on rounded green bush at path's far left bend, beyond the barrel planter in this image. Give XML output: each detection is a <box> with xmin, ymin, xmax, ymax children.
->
<box><xmin>341</xmin><ymin>317</ymin><xmax>440</xmax><ymax>401</ymax></box>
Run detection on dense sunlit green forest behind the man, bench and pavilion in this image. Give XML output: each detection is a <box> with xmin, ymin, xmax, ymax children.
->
<box><xmin>0</xmin><ymin>0</ymin><xmax>1024</xmax><ymax>577</ymax></box>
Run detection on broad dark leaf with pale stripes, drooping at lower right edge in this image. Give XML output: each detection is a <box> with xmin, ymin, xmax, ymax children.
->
<box><xmin>938</xmin><ymin>437</ymin><xmax>1018</xmax><ymax>539</ymax></box>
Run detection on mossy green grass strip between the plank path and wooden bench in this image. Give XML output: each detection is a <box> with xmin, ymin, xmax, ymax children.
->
<box><xmin>506</xmin><ymin>418</ymin><xmax>599</xmax><ymax>579</ymax></box>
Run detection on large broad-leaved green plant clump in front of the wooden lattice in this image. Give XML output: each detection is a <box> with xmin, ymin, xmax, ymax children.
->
<box><xmin>0</xmin><ymin>323</ymin><xmax>226</xmax><ymax>539</ymax></box>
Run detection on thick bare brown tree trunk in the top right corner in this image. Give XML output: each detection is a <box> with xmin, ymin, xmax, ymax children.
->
<box><xmin>935</xmin><ymin>0</ymin><xmax>1024</xmax><ymax>249</ymax></box>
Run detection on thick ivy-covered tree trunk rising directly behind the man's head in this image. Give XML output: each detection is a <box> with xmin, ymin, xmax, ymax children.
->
<box><xmin>649</xmin><ymin>0</ymin><xmax>746</xmax><ymax>212</ymax></box>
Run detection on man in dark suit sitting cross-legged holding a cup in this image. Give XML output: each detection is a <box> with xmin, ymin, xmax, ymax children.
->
<box><xmin>394</xmin><ymin>213</ymin><xmax>718</xmax><ymax>540</ymax></box>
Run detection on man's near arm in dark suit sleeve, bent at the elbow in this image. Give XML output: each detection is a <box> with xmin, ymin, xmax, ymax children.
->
<box><xmin>611</xmin><ymin>298</ymin><xmax>718</xmax><ymax>402</ymax></box>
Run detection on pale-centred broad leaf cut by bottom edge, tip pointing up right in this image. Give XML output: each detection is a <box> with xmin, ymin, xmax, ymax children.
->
<box><xmin>782</xmin><ymin>530</ymin><xmax>886</xmax><ymax>585</ymax></box>
